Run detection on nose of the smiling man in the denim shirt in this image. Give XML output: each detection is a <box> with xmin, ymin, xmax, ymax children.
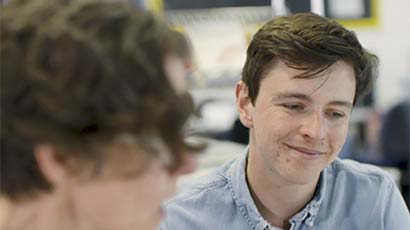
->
<box><xmin>300</xmin><ymin>111</ymin><xmax>327</xmax><ymax>141</ymax></box>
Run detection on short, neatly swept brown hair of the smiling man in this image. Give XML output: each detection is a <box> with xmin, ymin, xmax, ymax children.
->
<box><xmin>242</xmin><ymin>13</ymin><xmax>378</xmax><ymax>104</ymax></box>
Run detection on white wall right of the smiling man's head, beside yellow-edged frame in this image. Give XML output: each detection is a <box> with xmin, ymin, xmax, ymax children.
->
<box><xmin>352</xmin><ymin>0</ymin><xmax>410</xmax><ymax>110</ymax></box>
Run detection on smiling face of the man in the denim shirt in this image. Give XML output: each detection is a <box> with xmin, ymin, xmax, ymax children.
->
<box><xmin>237</xmin><ymin>62</ymin><xmax>355</xmax><ymax>184</ymax></box>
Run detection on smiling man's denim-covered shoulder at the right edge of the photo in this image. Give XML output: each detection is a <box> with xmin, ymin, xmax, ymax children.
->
<box><xmin>317</xmin><ymin>159</ymin><xmax>408</xmax><ymax>229</ymax></box>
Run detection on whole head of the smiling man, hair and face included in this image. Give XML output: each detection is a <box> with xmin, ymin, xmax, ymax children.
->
<box><xmin>236</xmin><ymin>13</ymin><xmax>377</xmax><ymax>184</ymax></box>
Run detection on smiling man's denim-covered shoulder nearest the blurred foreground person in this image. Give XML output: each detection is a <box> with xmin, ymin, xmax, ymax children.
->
<box><xmin>161</xmin><ymin>163</ymin><xmax>234</xmax><ymax>229</ymax></box>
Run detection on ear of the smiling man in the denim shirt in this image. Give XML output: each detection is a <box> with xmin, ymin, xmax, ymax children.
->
<box><xmin>235</xmin><ymin>81</ymin><xmax>254</xmax><ymax>128</ymax></box>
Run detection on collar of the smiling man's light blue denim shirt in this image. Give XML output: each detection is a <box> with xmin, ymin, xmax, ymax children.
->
<box><xmin>227</xmin><ymin>146</ymin><xmax>326</xmax><ymax>229</ymax></box>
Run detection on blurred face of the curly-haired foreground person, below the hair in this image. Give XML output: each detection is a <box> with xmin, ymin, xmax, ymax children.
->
<box><xmin>60</xmin><ymin>135</ymin><xmax>193</xmax><ymax>230</ymax></box>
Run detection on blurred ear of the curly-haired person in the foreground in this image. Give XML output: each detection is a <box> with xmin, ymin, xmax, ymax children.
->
<box><xmin>33</xmin><ymin>144</ymin><xmax>67</xmax><ymax>187</ymax></box>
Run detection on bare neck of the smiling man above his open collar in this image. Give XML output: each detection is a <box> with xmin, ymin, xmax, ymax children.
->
<box><xmin>246</xmin><ymin>151</ymin><xmax>319</xmax><ymax>228</ymax></box>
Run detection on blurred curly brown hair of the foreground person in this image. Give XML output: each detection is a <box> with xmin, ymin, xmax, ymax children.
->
<box><xmin>0</xmin><ymin>0</ymin><xmax>197</xmax><ymax>198</ymax></box>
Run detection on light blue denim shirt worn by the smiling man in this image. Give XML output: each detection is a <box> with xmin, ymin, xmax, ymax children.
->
<box><xmin>160</xmin><ymin>150</ymin><xmax>410</xmax><ymax>230</ymax></box>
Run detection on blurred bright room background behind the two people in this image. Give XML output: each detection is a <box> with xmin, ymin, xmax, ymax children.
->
<box><xmin>0</xmin><ymin>0</ymin><xmax>410</xmax><ymax>207</ymax></box>
